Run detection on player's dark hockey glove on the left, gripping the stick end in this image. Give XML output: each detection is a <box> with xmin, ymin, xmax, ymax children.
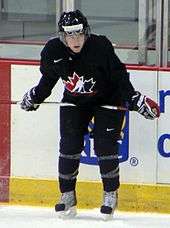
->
<box><xmin>20</xmin><ymin>87</ymin><xmax>39</xmax><ymax>111</ymax></box>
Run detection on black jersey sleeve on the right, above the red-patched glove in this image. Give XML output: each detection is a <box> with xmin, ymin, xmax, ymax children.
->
<box><xmin>102</xmin><ymin>38</ymin><xmax>135</xmax><ymax>104</ymax></box>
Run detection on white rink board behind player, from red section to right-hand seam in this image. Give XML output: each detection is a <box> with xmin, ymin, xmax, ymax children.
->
<box><xmin>11</xmin><ymin>65</ymin><xmax>165</xmax><ymax>183</ymax></box>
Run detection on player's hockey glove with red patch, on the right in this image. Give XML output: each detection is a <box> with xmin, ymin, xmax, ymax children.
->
<box><xmin>129</xmin><ymin>91</ymin><xmax>160</xmax><ymax>120</ymax></box>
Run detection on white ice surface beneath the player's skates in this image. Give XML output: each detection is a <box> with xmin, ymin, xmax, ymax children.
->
<box><xmin>0</xmin><ymin>206</ymin><xmax>170</xmax><ymax>228</ymax></box>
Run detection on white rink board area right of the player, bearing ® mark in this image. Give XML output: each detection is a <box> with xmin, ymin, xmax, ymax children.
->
<box><xmin>120</xmin><ymin>70</ymin><xmax>157</xmax><ymax>183</ymax></box>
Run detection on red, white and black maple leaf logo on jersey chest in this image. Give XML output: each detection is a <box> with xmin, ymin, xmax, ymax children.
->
<box><xmin>63</xmin><ymin>72</ymin><xmax>96</xmax><ymax>94</ymax></box>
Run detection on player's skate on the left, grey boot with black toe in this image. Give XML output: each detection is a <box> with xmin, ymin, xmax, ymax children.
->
<box><xmin>55</xmin><ymin>191</ymin><xmax>77</xmax><ymax>219</ymax></box>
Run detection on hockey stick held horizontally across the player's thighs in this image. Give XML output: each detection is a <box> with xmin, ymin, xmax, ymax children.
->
<box><xmin>0</xmin><ymin>100</ymin><xmax>128</xmax><ymax>111</ymax></box>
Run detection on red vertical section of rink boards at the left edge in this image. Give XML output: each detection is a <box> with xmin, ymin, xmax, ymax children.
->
<box><xmin>0</xmin><ymin>61</ymin><xmax>11</xmax><ymax>202</ymax></box>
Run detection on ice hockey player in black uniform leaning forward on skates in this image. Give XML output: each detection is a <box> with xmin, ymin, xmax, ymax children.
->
<box><xmin>21</xmin><ymin>10</ymin><xmax>160</xmax><ymax>220</ymax></box>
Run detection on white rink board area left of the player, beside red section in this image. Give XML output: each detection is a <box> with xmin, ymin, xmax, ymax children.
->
<box><xmin>11</xmin><ymin>65</ymin><xmax>63</xmax><ymax>179</ymax></box>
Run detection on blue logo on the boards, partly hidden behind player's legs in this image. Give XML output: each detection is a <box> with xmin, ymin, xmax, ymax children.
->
<box><xmin>80</xmin><ymin>112</ymin><xmax>129</xmax><ymax>165</ymax></box>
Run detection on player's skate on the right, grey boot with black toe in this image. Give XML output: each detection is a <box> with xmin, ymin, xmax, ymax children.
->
<box><xmin>100</xmin><ymin>191</ymin><xmax>118</xmax><ymax>220</ymax></box>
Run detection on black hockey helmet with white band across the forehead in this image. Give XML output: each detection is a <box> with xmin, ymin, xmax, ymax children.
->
<box><xmin>58</xmin><ymin>10</ymin><xmax>90</xmax><ymax>35</ymax></box>
